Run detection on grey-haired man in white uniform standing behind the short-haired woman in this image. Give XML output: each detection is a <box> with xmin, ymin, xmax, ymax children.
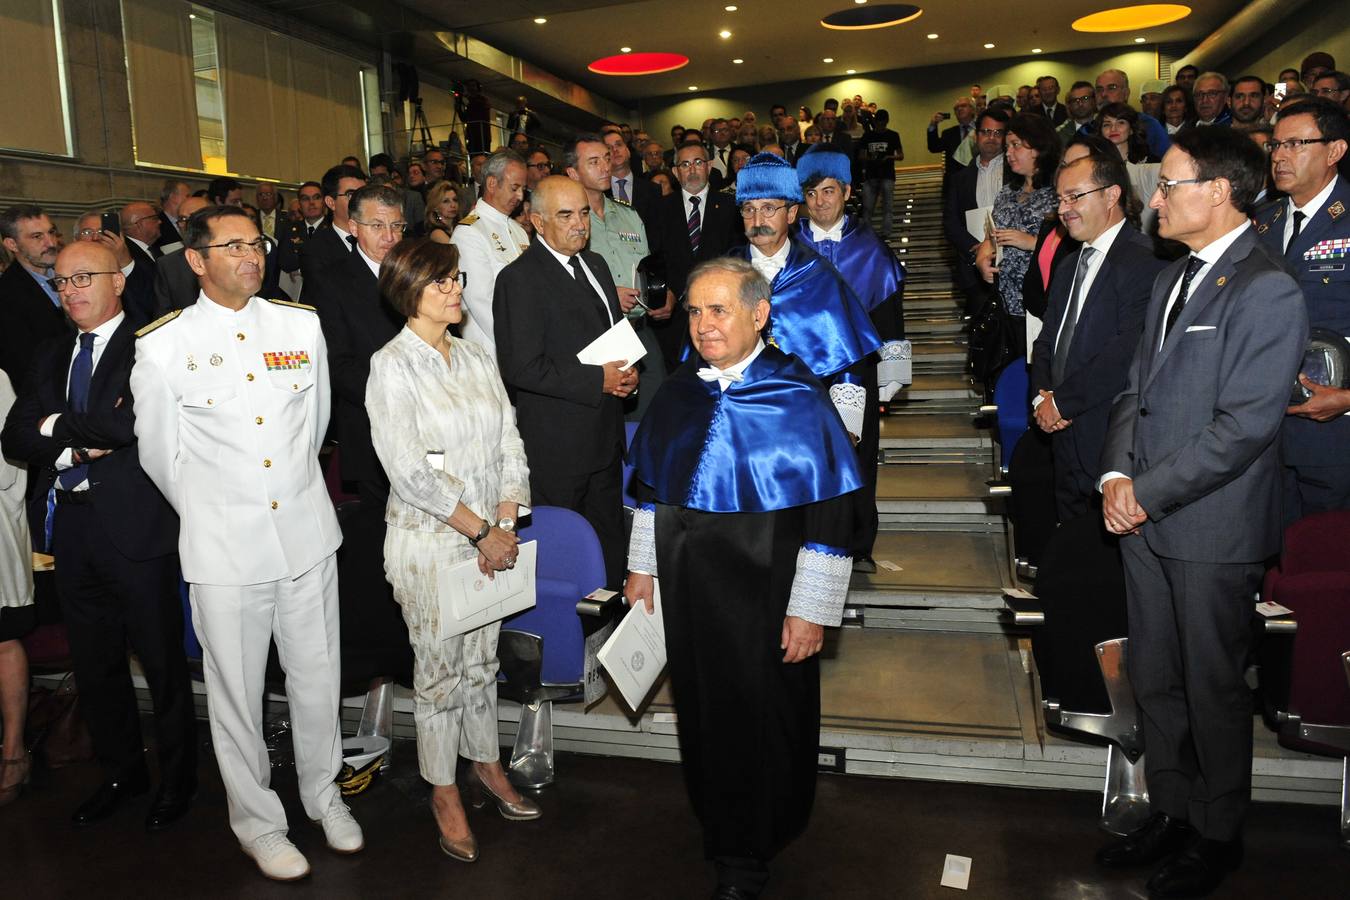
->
<box><xmin>450</xmin><ymin>150</ymin><xmax>529</xmax><ymax>354</ymax></box>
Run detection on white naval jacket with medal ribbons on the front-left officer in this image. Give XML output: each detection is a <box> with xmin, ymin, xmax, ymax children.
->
<box><xmin>131</xmin><ymin>294</ymin><xmax>342</xmax><ymax>584</ymax></box>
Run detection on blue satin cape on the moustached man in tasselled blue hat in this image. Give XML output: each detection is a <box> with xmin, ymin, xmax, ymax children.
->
<box><xmin>728</xmin><ymin>239</ymin><xmax>882</xmax><ymax>381</ymax></box>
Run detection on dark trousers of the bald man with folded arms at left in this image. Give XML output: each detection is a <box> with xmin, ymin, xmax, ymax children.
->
<box><xmin>51</xmin><ymin>505</ymin><xmax>197</xmax><ymax>793</ymax></box>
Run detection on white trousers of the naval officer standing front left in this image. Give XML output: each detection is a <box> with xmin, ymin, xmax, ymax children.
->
<box><xmin>190</xmin><ymin>556</ymin><xmax>342</xmax><ymax>843</ymax></box>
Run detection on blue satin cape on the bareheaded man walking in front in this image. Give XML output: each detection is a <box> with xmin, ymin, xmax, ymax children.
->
<box><xmin>629</xmin><ymin>347</ymin><xmax>863</xmax><ymax>513</ymax></box>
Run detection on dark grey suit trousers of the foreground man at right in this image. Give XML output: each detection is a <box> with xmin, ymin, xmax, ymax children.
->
<box><xmin>1121</xmin><ymin>536</ymin><xmax>1262</xmax><ymax>841</ymax></box>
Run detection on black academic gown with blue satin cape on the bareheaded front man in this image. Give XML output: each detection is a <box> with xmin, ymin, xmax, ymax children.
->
<box><xmin>633</xmin><ymin>347</ymin><xmax>861</xmax><ymax>888</ymax></box>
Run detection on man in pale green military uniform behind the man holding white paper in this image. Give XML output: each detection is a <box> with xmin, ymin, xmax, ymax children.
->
<box><xmin>563</xmin><ymin>134</ymin><xmax>666</xmax><ymax>422</ymax></box>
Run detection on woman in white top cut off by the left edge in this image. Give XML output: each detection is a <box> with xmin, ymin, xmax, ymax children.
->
<box><xmin>0</xmin><ymin>371</ymin><xmax>38</xmax><ymax>807</ymax></box>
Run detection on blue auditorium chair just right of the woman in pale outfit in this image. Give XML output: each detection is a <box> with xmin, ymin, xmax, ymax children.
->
<box><xmin>497</xmin><ymin>506</ymin><xmax>605</xmax><ymax>788</ymax></box>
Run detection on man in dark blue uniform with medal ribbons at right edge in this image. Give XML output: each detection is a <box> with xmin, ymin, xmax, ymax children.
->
<box><xmin>1256</xmin><ymin>97</ymin><xmax>1350</xmax><ymax>522</ymax></box>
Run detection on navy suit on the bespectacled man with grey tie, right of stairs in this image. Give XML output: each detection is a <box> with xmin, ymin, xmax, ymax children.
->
<box><xmin>1031</xmin><ymin>223</ymin><xmax>1165</xmax><ymax>522</ymax></box>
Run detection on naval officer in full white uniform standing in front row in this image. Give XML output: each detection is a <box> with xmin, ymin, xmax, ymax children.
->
<box><xmin>131</xmin><ymin>206</ymin><xmax>365</xmax><ymax>881</ymax></box>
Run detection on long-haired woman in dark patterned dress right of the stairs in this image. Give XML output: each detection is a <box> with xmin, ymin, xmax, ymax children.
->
<box><xmin>977</xmin><ymin>115</ymin><xmax>1060</xmax><ymax>356</ymax></box>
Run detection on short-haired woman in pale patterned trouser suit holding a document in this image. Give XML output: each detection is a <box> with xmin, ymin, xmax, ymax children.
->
<box><xmin>366</xmin><ymin>240</ymin><xmax>540</xmax><ymax>862</ymax></box>
